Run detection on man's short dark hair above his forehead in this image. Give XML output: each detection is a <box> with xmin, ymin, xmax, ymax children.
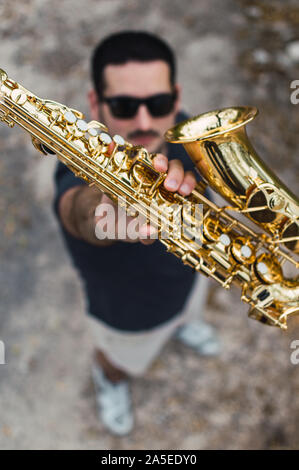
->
<box><xmin>91</xmin><ymin>31</ymin><xmax>175</xmax><ymax>99</ymax></box>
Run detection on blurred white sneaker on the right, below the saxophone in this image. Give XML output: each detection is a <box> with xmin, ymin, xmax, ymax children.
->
<box><xmin>176</xmin><ymin>321</ymin><xmax>221</xmax><ymax>356</ymax></box>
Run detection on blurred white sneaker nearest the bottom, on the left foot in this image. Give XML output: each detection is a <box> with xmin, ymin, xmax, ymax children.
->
<box><xmin>92</xmin><ymin>365</ymin><xmax>134</xmax><ymax>436</ymax></box>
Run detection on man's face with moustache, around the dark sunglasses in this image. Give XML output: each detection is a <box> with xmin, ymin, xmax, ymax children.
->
<box><xmin>89</xmin><ymin>60</ymin><xmax>180</xmax><ymax>153</ymax></box>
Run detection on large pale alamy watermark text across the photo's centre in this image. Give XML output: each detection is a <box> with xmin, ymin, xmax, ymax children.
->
<box><xmin>95</xmin><ymin>198</ymin><xmax>203</xmax><ymax>245</ymax></box>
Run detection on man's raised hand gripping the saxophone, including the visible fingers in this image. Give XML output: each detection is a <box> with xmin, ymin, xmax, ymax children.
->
<box><xmin>59</xmin><ymin>154</ymin><xmax>196</xmax><ymax>246</ymax></box>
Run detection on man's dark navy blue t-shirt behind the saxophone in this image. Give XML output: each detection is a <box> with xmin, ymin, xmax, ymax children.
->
<box><xmin>54</xmin><ymin>113</ymin><xmax>207</xmax><ymax>331</ymax></box>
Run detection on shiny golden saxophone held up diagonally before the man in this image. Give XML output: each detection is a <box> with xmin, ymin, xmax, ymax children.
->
<box><xmin>0</xmin><ymin>69</ymin><xmax>299</xmax><ymax>329</ymax></box>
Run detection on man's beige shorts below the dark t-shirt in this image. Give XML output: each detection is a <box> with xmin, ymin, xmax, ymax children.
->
<box><xmin>87</xmin><ymin>274</ymin><xmax>209</xmax><ymax>376</ymax></box>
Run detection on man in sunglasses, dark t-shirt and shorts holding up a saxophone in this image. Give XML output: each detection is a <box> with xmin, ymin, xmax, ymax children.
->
<box><xmin>55</xmin><ymin>32</ymin><xmax>218</xmax><ymax>435</ymax></box>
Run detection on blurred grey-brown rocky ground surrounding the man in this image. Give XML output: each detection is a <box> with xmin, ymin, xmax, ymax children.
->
<box><xmin>0</xmin><ymin>0</ymin><xmax>299</xmax><ymax>449</ymax></box>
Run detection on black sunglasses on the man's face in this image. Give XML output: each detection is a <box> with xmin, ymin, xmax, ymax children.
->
<box><xmin>102</xmin><ymin>91</ymin><xmax>177</xmax><ymax>119</ymax></box>
